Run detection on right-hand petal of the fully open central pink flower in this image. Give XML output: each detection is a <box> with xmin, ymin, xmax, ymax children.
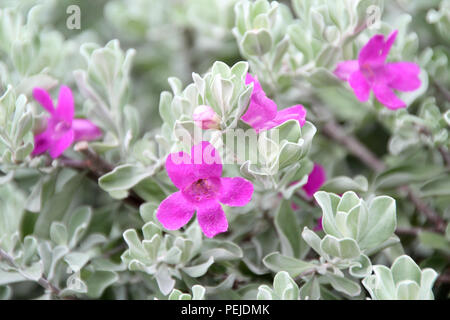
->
<box><xmin>219</xmin><ymin>177</ymin><xmax>253</xmax><ymax>207</ymax></box>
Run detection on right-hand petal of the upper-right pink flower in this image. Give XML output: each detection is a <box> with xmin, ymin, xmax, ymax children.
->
<box><xmin>385</xmin><ymin>62</ymin><xmax>421</xmax><ymax>91</ymax></box>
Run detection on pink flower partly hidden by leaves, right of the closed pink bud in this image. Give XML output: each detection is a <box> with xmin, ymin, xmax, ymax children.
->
<box><xmin>241</xmin><ymin>73</ymin><xmax>306</xmax><ymax>132</ymax></box>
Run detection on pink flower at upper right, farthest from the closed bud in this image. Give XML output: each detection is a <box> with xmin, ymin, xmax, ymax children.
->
<box><xmin>334</xmin><ymin>30</ymin><xmax>421</xmax><ymax>110</ymax></box>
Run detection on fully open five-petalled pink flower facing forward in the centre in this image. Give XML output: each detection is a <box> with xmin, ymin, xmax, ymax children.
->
<box><xmin>156</xmin><ymin>141</ymin><xmax>253</xmax><ymax>238</ymax></box>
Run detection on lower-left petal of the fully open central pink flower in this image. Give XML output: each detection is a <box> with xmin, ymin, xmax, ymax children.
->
<box><xmin>156</xmin><ymin>191</ymin><xmax>195</xmax><ymax>230</ymax></box>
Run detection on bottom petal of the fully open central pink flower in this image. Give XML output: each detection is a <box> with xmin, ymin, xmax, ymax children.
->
<box><xmin>197</xmin><ymin>201</ymin><xmax>228</xmax><ymax>238</ymax></box>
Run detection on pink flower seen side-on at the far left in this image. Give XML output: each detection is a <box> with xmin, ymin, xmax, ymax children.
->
<box><xmin>31</xmin><ymin>86</ymin><xmax>102</xmax><ymax>159</ymax></box>
